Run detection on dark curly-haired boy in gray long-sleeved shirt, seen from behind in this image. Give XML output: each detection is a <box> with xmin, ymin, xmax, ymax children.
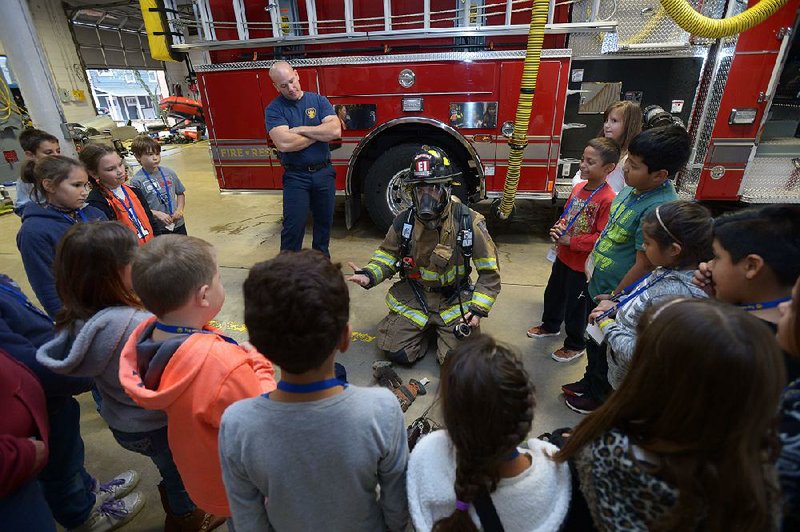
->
<box><xmin>219</xmin><ymin>250</ymin><xmax>408</xmax><ymax>532</ymax></box>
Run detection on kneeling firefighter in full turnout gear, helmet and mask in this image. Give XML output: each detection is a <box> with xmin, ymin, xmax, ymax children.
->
<box><xmin>348</xmin><ymin>146</ymin><xmax>500</xmax><ymax>364</ymax></box>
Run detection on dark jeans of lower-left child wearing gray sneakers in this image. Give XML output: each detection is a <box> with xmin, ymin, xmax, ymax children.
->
<box><xmin>39</xmin><ymin>397</ymin><xmax>95</xmax><ymax>528</ymax></box>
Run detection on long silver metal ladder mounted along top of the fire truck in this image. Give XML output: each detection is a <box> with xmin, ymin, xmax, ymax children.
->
<box><xmin>166</xmin><ymin>0</ymin><xmax>617</xmax><ymax>51</ymax></box>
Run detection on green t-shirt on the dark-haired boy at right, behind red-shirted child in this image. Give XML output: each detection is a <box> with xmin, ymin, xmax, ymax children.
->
<box><xmin>589</xmin><ymin>180</ymin><xmax>678</xmax><ymax>298</ymax></box>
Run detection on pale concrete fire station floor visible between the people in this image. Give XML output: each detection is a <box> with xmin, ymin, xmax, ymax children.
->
<box><xmin>0</xmin><ymin>142</ymin><xmax>586</xmax><ymax>531</ymax></box>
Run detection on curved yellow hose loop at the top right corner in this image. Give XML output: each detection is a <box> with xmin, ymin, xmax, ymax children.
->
<box><xmin>661</xmin><ymin>0</ymin><xmax>788</xmax><ymax>39</ymax></box>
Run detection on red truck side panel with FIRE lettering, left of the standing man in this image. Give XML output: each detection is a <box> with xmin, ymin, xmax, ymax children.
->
<box><xmin>199</xmin><ymin>70</ymin><xmax>283</xmax><ymax>189</ymax></box>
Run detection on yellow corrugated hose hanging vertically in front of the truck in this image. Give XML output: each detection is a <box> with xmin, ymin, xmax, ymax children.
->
<box><xmin>497</xmin><ymin>0</ymin><xmax>550</xmax><ymax>220</ymax></box>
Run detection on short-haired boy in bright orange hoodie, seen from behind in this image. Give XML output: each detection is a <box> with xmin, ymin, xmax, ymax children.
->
<box><xmin>119</xmin><ymin>235</ymin><xmax>275</xmax><ymax>516</ymax></box>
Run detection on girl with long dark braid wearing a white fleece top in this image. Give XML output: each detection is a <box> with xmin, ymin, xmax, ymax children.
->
<box><xmin>407</xmin><ymin>335</ymin><xmax>571</xmax><ymax>532</ymax></box>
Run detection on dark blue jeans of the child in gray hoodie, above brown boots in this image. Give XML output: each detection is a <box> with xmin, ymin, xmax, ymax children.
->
<box><xmin>111</xmin><ymin>427</ymin><xmax>197</xmax><ymax>516</ymax></box>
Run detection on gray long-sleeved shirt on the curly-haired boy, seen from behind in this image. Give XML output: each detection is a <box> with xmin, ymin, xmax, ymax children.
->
<box><xmin>219</xmin><ymin>386</ymin><xmax>408</xmax><ymax>532</ymax></box>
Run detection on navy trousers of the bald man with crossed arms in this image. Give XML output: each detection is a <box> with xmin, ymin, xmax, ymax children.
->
<box><xmin>281</xmin><ymin>165</ymin><xmax>336</xmax><ymax>257</ymax></box>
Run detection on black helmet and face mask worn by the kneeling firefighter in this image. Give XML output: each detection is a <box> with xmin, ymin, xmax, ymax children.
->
<box><xmin>403</xmin><ymin>146</ymin><xmax>456</xmax><ymax>222</ymax></box>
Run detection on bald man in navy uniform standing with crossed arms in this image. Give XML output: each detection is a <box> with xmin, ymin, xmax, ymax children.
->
<box><xmin>264</xmin><ymin>61</ymin><xmax>342</xmax><ymax>256</ymax></box>
